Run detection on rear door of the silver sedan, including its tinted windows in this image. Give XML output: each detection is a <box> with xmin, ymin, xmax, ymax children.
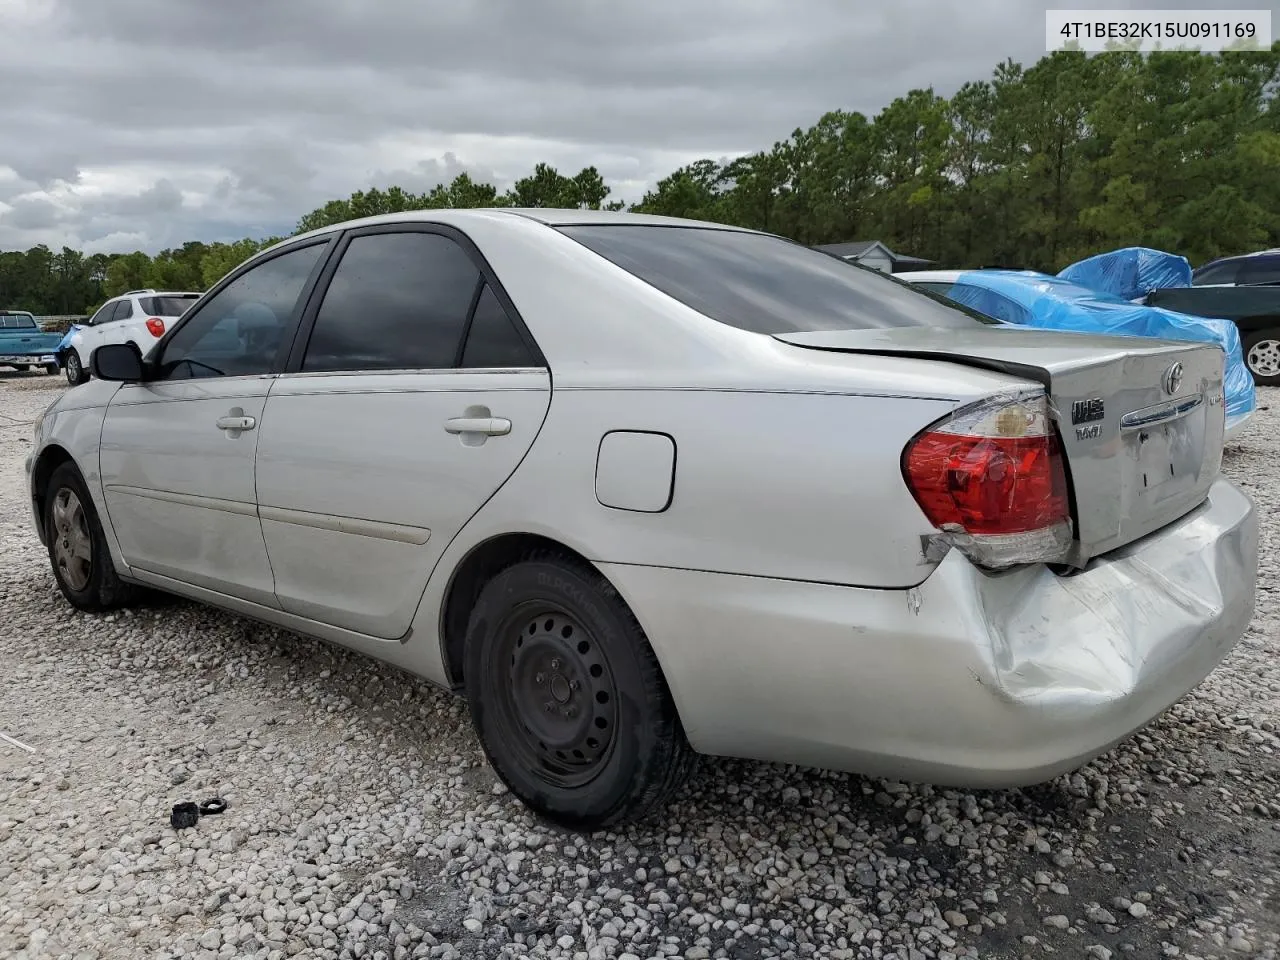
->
<box><xmin>257</xmin><ymin>225</ymin><xmax>550</xmax><ymax>640</ymax></box>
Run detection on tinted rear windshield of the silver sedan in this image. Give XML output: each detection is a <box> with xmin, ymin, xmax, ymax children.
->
<box><xmin>559</xmin><ymin>224</ymin><xmax>996</xmax><ymax>334</ymax></box>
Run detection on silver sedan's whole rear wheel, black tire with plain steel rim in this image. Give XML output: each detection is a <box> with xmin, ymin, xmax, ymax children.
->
<box><xmin>465</xmin><ymin>552</ymin><xmax>698</xmax><ymax>829</ymax></box>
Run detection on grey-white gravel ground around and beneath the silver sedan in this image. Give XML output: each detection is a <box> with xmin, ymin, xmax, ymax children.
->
<box><xmin>0</xmin><ymin>375</ymin><xmax>1280</xmax><ymax>960</ymax></box>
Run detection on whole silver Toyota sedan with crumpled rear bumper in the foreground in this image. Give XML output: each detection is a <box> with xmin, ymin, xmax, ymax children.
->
<box><xmin>27</xmin><ymin>210</ymin><xmax>1257</xmax><ymax>828</ymax></box>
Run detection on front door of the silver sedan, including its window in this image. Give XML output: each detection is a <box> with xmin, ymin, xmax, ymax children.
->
<box><xmin>101</xmin><ymin>242</ymin><xmax>326</xmax><ymax>607</ymax></box>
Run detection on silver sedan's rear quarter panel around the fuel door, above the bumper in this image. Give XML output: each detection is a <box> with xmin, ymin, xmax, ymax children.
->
<box><xmin>419</xmin><ymin>389</ymin><xmax>955</xmax><ymax>588</ymax></box>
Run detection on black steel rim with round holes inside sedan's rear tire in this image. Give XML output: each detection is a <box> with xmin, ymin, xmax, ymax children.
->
<box><xmin>493</xmin><ymin>603</ymin><xmax>618</xmax><ymax>788</ymax></box>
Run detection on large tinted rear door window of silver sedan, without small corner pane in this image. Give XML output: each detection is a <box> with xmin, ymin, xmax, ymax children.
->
<box><xmin>302</xmin><ymin>233</ymin><xmax>480</xmax><ymax>370</ymax></box>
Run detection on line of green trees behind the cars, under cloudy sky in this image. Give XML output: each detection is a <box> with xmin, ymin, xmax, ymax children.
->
<box><xmin>0</xmin><ymin>44</ymin><xmax>1280</xmax><ymax>314</ymax></box>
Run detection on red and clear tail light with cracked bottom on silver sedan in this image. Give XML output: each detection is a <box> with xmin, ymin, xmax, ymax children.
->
<box><xmin>902</xmin><ymin>392</ymin><xmax>1071</xmax><ymax>567</ymax></box>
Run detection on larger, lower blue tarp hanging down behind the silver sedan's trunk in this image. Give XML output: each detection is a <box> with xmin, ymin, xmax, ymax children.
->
<box><xmin>946</xmin><ymin>270</ymin><xmax>1257</xmax><ymax>424</ymax></box>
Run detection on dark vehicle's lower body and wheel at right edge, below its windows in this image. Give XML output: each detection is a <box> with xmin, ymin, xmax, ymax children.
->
<box><xmin>1142</xmin><ymin>284</ymin><xmax>1280</xmax><ymax>387</ymax></box>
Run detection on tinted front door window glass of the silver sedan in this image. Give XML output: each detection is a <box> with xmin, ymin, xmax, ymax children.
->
<box><xmin>159</xmin><ymin>243</ymin><xmax>326</xmax><ymax>380</ymax></box>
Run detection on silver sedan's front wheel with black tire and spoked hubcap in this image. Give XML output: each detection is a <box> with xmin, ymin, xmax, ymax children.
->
<box><xmin>44</xmin><ymin>463</ymin><xmax>137</xmax><ymax>613</ymax></box>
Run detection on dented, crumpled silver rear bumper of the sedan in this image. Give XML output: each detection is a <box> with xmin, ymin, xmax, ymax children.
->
<box><xmin>602</xmin><ymin>481</ymin><xmax>1257</xmax><ymax>787</ymax></box>
